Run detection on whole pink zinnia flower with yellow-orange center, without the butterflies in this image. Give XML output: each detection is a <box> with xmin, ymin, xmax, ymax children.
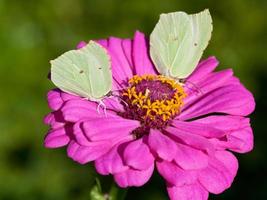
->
<box><xmin>44</xmin><ymin>32</ymin><xmax>255</xmax><ymax>200</ymax></box>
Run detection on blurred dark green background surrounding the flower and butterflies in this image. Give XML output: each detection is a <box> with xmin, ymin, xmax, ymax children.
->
<box><xmin>0</xmin><ymin>0</ymin><xmax>267</xmax><ymax>200</ymax></box>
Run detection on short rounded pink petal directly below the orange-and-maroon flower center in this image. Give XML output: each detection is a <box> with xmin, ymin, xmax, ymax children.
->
<box><xmin>148</xmin><ymin>130</ymin><xmax>177</xmax><ymax>161</ymax></box>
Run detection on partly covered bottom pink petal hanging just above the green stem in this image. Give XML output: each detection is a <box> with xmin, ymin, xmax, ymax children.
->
<box><xmin>114</xmin><ymin>165</ymin><xmax>154</xmax><ymax>188</ymax></box>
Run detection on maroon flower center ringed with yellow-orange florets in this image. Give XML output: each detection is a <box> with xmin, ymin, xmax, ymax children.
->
<box><xmin>121</xmin><ymin>75</ymin><xmax>186</xmax><ymax>136</ymax></box>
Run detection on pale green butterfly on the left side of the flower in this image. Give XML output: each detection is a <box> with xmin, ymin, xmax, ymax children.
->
<box><xmin>51</xmin><ymin>41</ymin><xmax>112</xmax><ymax>103</ymax></box>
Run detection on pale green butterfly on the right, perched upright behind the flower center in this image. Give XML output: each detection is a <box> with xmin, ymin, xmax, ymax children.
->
<box><xmin>150</xmin><ymin>9</ymin><xmax>212</xmax><ymax>80</ymax></box>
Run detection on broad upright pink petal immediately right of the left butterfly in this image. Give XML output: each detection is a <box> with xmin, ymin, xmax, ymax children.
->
<box><xmin>108</xmin><ymin>37</ymin><xmax>133</xmax><ymax>85</ymax></box>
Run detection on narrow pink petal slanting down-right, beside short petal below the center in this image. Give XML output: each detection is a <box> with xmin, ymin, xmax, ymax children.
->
<box><xmin>166</xmin><ymin>127</ymin><xmax>214</xmax><ymax>154</ymax></box>
